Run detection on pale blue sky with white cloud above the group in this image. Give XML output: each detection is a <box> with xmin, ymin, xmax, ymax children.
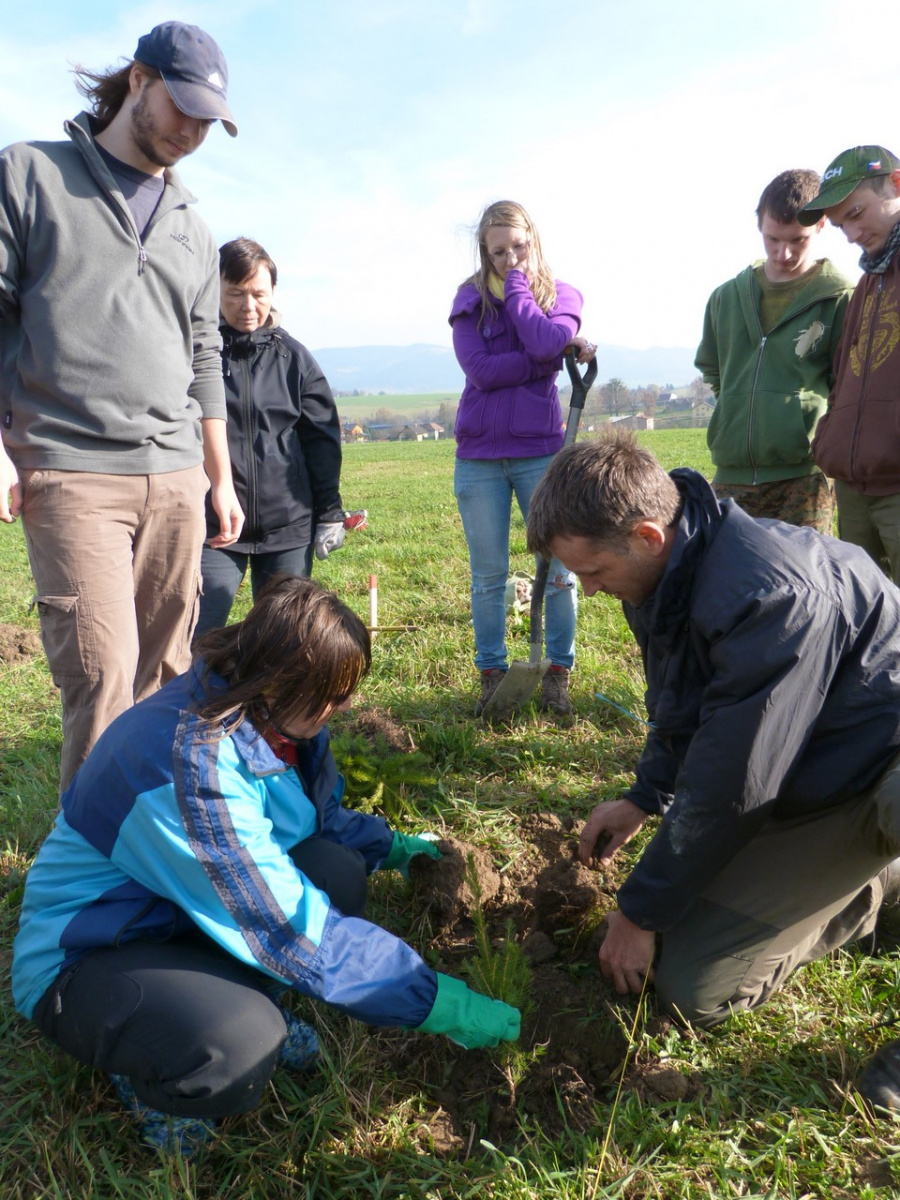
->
<box><xmin>0</xmin><ymin>0</ymin><xmax>900</xmax><ymax>360</ymax></box>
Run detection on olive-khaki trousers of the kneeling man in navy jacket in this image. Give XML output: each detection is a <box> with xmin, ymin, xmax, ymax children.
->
<box><xmin>656</xmin><ymin>764</ymin><xmax>900</xmax><ymax>1026</ymax></box>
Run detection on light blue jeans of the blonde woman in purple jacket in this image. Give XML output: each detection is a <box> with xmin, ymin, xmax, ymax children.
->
<box><xmin>454</xmin><ymin>455</ymin><xmax>578</xmax><ymax>671</ymax></box>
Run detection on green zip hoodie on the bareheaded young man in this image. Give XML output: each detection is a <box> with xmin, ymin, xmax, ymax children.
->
<box><xmin>695</xmin><ymin>258</ymin><xmax>853</xmax><ymax>484</ymax></box>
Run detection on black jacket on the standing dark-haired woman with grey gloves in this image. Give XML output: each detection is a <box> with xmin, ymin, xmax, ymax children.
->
<box><xmin>206</xmin><ymin>325</ymin><xmax>343</xmax><ymax>554</ymax></box>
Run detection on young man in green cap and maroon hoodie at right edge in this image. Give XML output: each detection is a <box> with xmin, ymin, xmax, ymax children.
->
<box><xmin>799</xmin><ymin>146</ymin><xmax>900</xmax><ymax>582</ymax></box>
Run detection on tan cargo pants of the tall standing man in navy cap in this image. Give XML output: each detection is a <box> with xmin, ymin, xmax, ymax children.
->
<box><xmin>22</xmin><ymin>467</ymin><xmax>209</xmax><ymax>791</ymax></box>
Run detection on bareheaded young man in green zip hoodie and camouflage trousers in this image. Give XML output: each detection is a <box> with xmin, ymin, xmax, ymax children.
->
<box><xmin>695</xmin><ymin>170</ymin><xmax>853</xmax><ymax>534</ymax></box>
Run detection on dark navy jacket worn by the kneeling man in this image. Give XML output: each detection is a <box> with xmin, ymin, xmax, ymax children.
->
<box><xmin>619</xmin><ymin>468</ymin><xmax>900</xmax><ymax>931</ymax></box>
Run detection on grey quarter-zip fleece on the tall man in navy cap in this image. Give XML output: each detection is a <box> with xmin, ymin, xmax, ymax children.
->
<box><xmin>0</xmin><ymin>113</ymin><xmax>226</xmax><ymax>475</ymax></box>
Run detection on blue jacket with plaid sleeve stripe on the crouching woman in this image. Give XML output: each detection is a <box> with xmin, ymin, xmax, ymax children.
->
<box><xmin>12</xmin><ymin>664</ymin><xmax>437</xmax><ymax>1028</ymax></box>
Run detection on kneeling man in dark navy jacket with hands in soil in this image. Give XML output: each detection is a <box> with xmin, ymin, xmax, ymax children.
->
<box><xmin>528</xmin><ymin>434</ymin><xmax>900</xmax><ymax>1099</ymax></box>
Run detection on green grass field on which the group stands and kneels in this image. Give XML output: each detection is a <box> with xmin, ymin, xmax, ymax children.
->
<box><xmin>0</xmin><ymin>434</ymin><xmax>900</xmax><ymax>1200</ymax></box>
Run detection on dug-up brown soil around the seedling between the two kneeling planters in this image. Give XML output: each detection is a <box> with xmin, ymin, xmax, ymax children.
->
<box><xmin>400</xmin><ymin>814</ymin><xmax>662</xmax><ymax>1152</ymax></box>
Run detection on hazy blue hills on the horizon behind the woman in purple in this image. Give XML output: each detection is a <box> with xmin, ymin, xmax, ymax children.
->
<box><xmin>313</xmin><ymin>342</ymin><xmax>697</xmax><ymax>397</ymax></box>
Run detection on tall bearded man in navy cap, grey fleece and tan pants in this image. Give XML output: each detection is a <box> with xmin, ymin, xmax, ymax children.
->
<box><xmin>0</xmin><ymin>22</ymin><xmax>244</xmax><ymax>788</ymax></box>
